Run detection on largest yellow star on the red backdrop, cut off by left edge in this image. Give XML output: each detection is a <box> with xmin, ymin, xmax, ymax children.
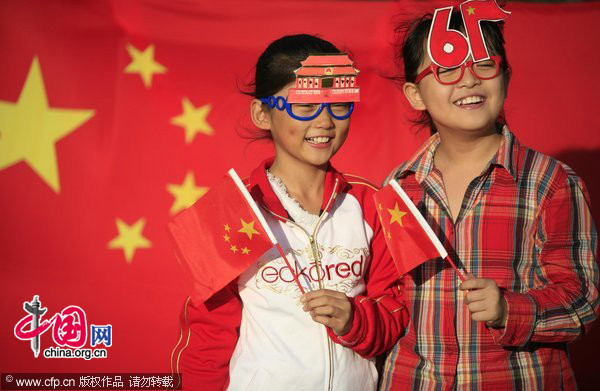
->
<box><xmin>0</xmin><ymin>57</ymin><xmax>94</xmax><ymax>193</ymax></box>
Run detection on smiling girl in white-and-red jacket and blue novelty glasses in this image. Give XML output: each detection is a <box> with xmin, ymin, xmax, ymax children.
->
<box><xmin>172</xmin><ymin>35</ymin><xmax>407</xmax><ymax>391</ymax></box>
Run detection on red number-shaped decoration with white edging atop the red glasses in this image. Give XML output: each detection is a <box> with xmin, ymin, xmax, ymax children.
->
<box><xmin>427</xmin><ymin>0</ymin><xmax>510</xmax><ymax>68</ymax></box>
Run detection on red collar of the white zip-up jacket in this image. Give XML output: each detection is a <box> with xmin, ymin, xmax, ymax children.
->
<box><xmin>248</xmin><ymin>157</ymin><xmax>348</xmax><ymax>224</ymax></box>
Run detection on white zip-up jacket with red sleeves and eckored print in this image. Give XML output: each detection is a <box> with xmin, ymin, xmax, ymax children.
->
<box><xmin>172</xmin><ymin>161</ymin><xmax>407</xmax><ymax>391</ymax></box>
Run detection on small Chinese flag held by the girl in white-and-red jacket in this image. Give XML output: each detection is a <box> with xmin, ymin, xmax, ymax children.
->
<box><xmin>169</xmin><ymin>169</ymin><xmax>277</xmax><ymax>303</ymax></box>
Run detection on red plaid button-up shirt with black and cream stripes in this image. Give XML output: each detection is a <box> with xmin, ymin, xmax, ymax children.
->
<box><xmin>382</xmin><ymin>128</ymin><xmax>599</xmax><ymax>390</ymax></box>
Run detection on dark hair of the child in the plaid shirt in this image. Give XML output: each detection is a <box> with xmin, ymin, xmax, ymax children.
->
<box><xmin>395</xmin><ymin>10</ymin><xmax>511</xmax><ymax>134</ymax></box>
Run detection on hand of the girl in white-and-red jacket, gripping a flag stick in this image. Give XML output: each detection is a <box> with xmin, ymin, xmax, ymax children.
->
<box><xmin>300</xmin><ymin>289</ymin><xmax>353</xmax><ymax>335</ymax></box>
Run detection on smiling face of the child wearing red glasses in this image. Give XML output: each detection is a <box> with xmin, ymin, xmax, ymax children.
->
<box><xmin>404</xmin><ymin>52</ymin><xmax>506</xmax><ymax>134</ymax></box>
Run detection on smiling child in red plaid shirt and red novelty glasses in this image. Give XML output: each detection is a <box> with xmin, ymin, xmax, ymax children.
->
<box><xmin>382</xmin><ymin>3</ymin><xmax>599</xmax><ymax>390</ymax></box>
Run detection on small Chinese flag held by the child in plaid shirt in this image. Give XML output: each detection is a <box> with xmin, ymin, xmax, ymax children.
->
<box><xmin>373</xmin><ymin>179</ymin><xmax>463</xmax><ymax>279</ymax></box>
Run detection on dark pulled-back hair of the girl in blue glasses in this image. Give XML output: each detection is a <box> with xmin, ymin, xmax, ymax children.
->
<box><xmin>244</xmin><ymin>34</ymin><xmax>341</xmax><ymax>141</ymax></box>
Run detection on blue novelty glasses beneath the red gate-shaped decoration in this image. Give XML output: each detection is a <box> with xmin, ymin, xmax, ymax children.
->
<box><xmin>260</xmin><ymin>96</ymin><xmax>354</xmax><ymax>121</ymax></box>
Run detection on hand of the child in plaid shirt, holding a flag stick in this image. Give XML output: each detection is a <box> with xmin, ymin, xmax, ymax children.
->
<box><xmin>459</xmin><ymin>275</ymin><xmax>508</xmax><ymax>328</ymax></box>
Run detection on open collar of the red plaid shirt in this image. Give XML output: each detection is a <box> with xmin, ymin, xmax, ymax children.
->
<box><xmin>396</xmin><ymin>126</ymin><xmax>521</xmax><ymax>184</ymax></box>
